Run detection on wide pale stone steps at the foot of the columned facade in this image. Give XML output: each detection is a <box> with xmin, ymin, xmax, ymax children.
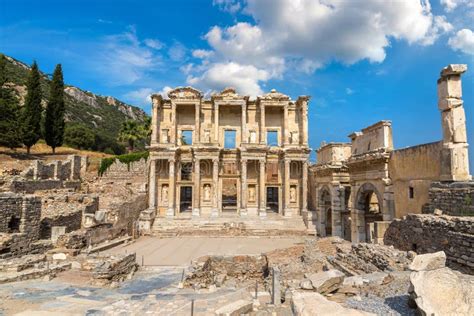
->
<box><xmin>152</xmin><ymin>213</ymin><xmax>307</xmax><ymax>237</ymax></box>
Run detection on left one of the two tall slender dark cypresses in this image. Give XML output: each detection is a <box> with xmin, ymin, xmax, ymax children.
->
<box><xmin>21</xmin><ymin>61</ymin><xmax>43</xmax><ymax>154</ymax></box>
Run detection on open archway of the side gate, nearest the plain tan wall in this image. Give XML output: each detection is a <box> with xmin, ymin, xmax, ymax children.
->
<box><xmin>355</xmin><ymin>183</ymin><xmax>383</xmax><ymax>242</ymax></box>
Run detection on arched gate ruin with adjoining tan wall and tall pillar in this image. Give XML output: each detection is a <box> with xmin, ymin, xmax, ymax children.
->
<box><xmin>308</xmin><ymin>65</ymin><xmax>472</xmax><ymax>242</ymax></box>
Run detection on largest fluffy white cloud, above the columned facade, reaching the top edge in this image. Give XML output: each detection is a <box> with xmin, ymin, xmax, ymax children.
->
<box><xmin>188</xmin><ymin>0</ymin><xmax>452</xmax><ymax>94</ymax></box>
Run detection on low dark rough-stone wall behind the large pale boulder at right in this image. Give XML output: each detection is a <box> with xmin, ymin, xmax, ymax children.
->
<box><xmin>384</xmin><ymin>214</ymin><xmax>474</xmax><ymax>274</ymax></box>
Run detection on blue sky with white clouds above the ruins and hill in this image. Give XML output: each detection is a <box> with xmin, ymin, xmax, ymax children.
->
<box><xmin>0</xmin><ymin>0</ymin><xmax>474</xmax><ymax>167</ymax></box>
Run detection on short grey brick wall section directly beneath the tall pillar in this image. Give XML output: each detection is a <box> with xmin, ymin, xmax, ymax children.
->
<box><xmin>423</xmin><ymin>182</ymin><xmax>474</xmax><ymax>216</ymax></box>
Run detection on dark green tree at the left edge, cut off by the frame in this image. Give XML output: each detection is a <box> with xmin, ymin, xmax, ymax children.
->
<box><xmin>0</xmin><ymin>54</ymin><xmax>21</xmax><ymax>149</ymax></box>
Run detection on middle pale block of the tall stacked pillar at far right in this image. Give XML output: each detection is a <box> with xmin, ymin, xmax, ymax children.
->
<box><xmin>441</xmin><ymin>107</ymin><xmax>467</xmax><ymax>143</ymax></box>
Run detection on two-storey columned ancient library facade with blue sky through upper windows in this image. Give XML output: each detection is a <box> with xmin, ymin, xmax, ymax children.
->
<box><xmin>142</xmin><ymin>87</ymin><xmax>310</xmax><ymax>228</ymax></box>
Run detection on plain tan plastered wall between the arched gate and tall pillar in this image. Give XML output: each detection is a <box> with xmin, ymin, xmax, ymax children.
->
<box><xmin>388</xmin><ymin>142</ymin><xmax>443</xmax><ymax>218</ymax></box>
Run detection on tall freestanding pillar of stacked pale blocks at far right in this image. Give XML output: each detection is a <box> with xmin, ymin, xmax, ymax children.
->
<box><xmin>438</xmin><ymin>65</ymin><xmax>471</xmax><ymax>181</ymax></box>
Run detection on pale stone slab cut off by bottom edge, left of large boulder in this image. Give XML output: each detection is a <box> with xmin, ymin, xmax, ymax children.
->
<box><xmin>291</xmin><ymin>292</ymin><xmax>375</xmax><ymax>316</ymax></box>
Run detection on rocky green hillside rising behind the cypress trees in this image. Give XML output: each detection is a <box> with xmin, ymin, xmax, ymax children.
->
<box><xmin>1</xmin><ymin>56</ymin><xmax>147</xmax><ymax>152</ymax></box>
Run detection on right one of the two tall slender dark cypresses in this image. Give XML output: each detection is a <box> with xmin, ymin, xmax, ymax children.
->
<box><xmin>44</xmin><ymin>64</ymin><xmax>65</xmax><ymax>154</ymax></box>
